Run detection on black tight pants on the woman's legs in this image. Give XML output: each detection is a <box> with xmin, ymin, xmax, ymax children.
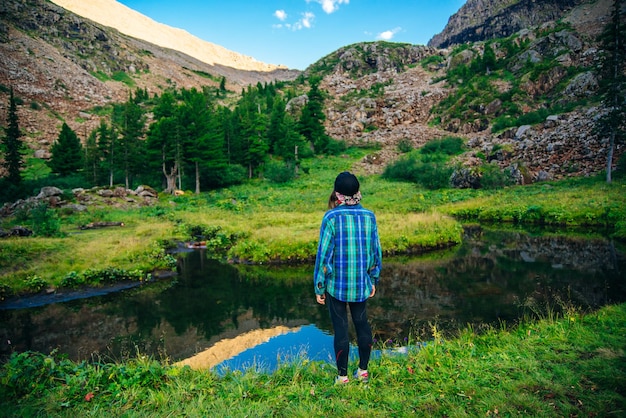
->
<box><xmin>326</xmin><ymin>293</ymin><xmax>372</xmax><ymax>376</ymax></box>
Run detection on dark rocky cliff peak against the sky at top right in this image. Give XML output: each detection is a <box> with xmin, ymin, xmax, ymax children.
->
<box><xmin>428</xmin><ymin>0</ymin><xmax>594</xmax><ymax>48</ymax></box>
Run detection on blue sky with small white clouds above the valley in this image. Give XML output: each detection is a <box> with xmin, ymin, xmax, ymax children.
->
<box><xmin>118</xmin><ymin>0</ymin><xmax>465</xmax><ymax>70</ymax></box>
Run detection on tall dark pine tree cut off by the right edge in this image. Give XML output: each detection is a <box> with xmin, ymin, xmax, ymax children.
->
<box><xmin>596</xmin><ymin>0</ymin><xmax>626</xmax><ymax>183</ymax></box>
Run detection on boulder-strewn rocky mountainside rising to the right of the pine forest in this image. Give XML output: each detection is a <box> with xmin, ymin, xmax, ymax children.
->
<box><xmin>307</xmin><ymin>0</ymin><xmax>624</xmax><ymax>183</ymax></box>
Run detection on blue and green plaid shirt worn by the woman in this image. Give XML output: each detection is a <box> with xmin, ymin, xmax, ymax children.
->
<box><xmin>313</xmin><ymin>204</ymin><xmax>382</xmax><ymax>302</ymax></box>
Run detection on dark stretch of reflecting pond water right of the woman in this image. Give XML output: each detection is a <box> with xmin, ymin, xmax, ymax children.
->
<box><xmin>369</xmin><ymin>229</ymin><xmax>626</xmax><ymax>340</ymax></box>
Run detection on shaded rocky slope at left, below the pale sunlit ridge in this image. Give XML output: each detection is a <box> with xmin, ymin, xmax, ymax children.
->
<box><xmin>0</xmin><ymin>0</ymin><xmax>300</xmax><ymax>163</ymax></box>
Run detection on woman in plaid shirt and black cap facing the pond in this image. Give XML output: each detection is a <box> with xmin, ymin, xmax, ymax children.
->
<box><xmin>314</xmin><ymin>171</ymin><xmax>382</xmax><ymax>384</ymax></box>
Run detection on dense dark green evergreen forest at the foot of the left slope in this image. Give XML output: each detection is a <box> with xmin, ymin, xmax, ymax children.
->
<box><xmin>4</xmin><ymin>79</ymin><xmax>343</xmax><ymax>202</ymax></box>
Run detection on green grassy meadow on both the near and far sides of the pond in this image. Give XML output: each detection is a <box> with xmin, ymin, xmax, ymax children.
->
<box><xmin>0</xmin><ymin>150</ymin><xmax>626</xmax><ymax>417</ymax></box>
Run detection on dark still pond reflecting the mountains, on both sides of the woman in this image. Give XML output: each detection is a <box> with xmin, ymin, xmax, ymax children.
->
<box><xmin>0</xmin><ymin>228</ymin><xmax>626</xmax><ymax>367</ymax></box>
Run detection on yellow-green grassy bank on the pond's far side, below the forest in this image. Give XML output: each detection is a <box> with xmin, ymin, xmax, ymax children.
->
<box><xmin>0</xmin><ymin>150</ymin><xmax>626</xmax><ymax>300</ymax></box>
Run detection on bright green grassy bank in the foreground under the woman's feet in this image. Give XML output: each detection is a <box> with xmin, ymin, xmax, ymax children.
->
<box><xmin>0</xmin><ymin>304</ymin><xmax>626</xmax><ymax>417</ymax></box>
